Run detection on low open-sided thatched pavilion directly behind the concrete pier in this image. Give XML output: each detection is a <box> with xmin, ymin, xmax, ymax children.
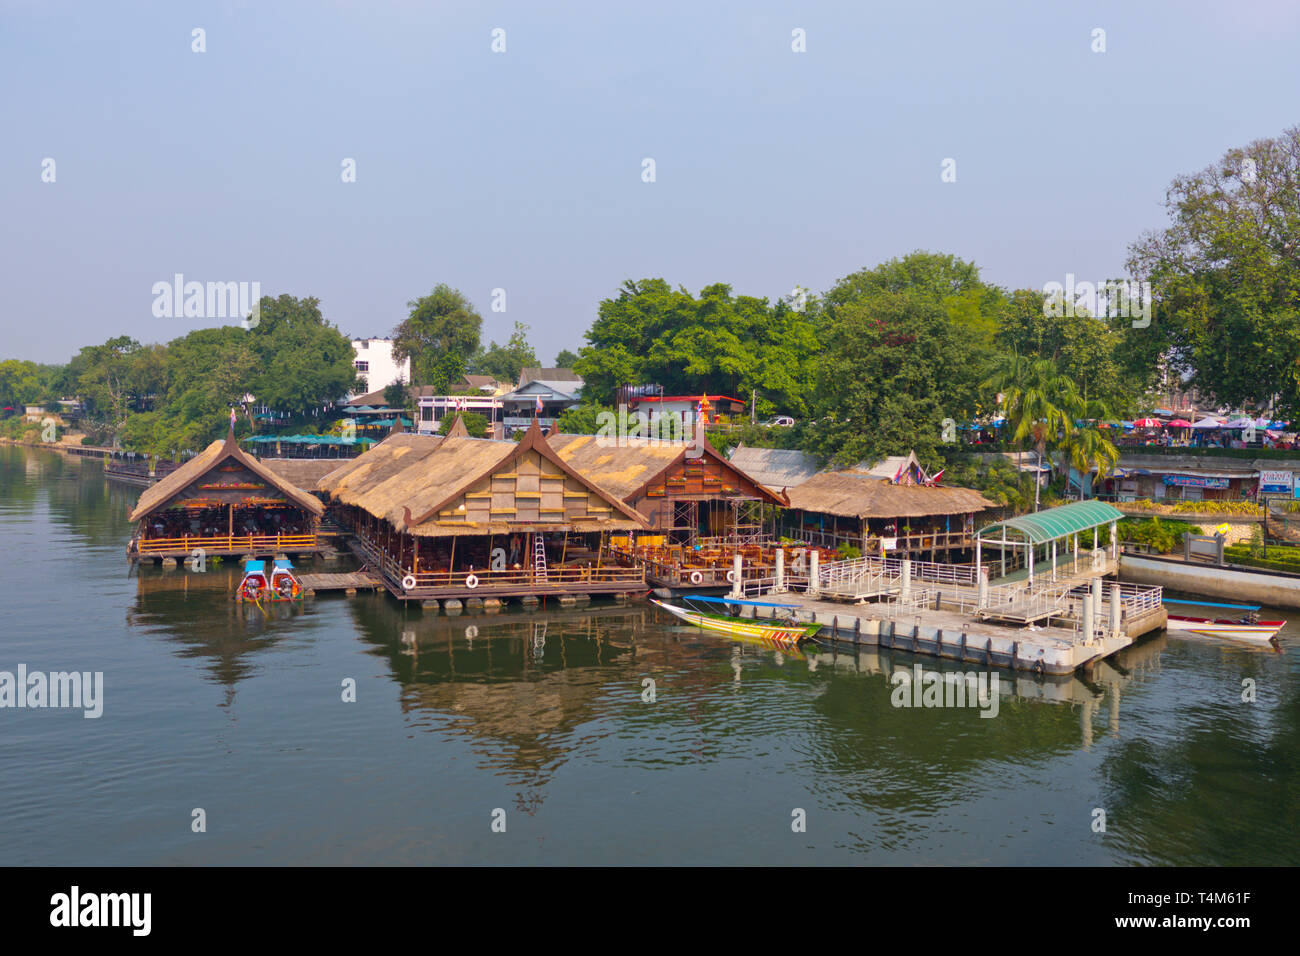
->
<box><xmin>781</xmin><ymin>454</ymin><xmax>995</xmax><ymax>561</ymax></box>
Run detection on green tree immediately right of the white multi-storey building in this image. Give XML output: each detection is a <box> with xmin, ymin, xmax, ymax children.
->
<box><xmin>393</xmin><ymin>284</ymin><xmax>484</xmax><ymax>393</ymax></box>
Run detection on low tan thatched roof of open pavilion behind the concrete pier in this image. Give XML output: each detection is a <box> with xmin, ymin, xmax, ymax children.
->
<box><xmin>787</xmin><ymin>471</ymin><xmax>995</xmax><ymax>518</ymax></box>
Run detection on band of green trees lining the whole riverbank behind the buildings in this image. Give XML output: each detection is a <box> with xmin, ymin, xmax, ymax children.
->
<box><xmin>0</xmin><ymin>127</ymin><xmax>1300</xmax><ymax>515</ymax></box>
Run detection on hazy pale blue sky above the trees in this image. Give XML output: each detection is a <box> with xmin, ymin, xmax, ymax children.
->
<box><xmin>0</xmin><ymin>0</ymin><xmax>1300</xmax><ymax>362</ymax></box>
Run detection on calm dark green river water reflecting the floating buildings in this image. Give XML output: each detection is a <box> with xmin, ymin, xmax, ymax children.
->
<box><xmin>0</xmin><ymin>447</ymin><xmax>1300</xmax><ymax>865</ymax></box>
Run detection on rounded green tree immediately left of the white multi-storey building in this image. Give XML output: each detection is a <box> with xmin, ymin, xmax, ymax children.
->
<box><xmin>244</xmin><ymin>295</ymin><xmax>356</xmax><ymax>415</ymax></box>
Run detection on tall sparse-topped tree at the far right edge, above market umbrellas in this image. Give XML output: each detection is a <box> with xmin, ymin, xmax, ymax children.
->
<box><xmin>1128</xmin><ymin>126</ymin><xmax>1300</xmax><ymax>418</ymax></box>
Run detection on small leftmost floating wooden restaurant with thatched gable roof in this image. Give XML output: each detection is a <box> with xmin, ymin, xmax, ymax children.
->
<box><xmin>127</xmin><ymin>429</ymin><xmax>325</xmax><ymax>561</ymax></box>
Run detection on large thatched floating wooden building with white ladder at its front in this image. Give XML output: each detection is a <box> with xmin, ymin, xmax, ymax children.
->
<box><xmin>309</xmin><ymin>420</ymin><xmax>646</xmax><ymax>601</ymax></box>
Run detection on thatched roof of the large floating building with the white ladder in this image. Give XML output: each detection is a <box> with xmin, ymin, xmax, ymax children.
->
<box><xmin>310</xmin><ymin>421</ymin><xmax>646</xmax><ymax>536</ymax></box>
